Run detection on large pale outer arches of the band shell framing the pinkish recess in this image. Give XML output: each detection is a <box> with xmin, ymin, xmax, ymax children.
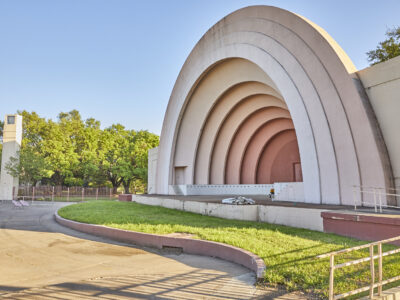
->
<box><xmin>156</xmin><ymin>6</ymin><xmax>391</xmax><ymax>204</ymax></box>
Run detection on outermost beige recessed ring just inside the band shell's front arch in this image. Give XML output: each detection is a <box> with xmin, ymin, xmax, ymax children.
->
<box><xmin>172</xmin><ymin>59</ymin><xmax>282</xmax><ymax>184</ymax></box>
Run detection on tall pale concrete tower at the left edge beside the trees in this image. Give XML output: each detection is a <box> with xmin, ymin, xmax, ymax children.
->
<box><xmin>0</xmin><ymin>115</ymin><xmax>22</xmax><ymax>200</ymax></box>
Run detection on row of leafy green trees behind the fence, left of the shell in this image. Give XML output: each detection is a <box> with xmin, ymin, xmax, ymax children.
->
<box><xmin>4</xmin><ymin>110</ymin><xmax>159</xmax><ymax>192</ymax></box>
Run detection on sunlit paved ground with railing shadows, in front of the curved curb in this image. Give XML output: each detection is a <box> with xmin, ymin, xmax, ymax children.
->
<box><xmin>0</xmin><ymin>202</ymin><xmax>308</xmax><ymax>299</ymax></box>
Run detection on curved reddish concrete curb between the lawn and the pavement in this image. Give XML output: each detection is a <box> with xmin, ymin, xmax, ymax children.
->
<box><xmin>54</xmin><ymin>212</ymin><xmax>266</xmax><ymax>280</ymax></box>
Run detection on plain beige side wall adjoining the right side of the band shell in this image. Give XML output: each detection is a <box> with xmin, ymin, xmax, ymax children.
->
<box><xmin>357</xmin><ymin>56</ymin><xmax>400</xmax><ymax>192</ymax></box>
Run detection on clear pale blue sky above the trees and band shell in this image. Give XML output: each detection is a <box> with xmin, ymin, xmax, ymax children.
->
<box><xmin>0</xmin><ymin>0</ymin><xmax>400</xmax><ymax>134</ymax></box>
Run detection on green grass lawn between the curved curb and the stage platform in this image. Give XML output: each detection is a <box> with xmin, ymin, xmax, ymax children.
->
<box><xmin>59</xmin><ymin>201</ymin><xmax>400</xmax><ymax>298</ymax></box>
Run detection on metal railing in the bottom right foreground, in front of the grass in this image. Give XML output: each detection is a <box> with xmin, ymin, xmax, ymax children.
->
<box><xmin>317</xmin><ymin>236</ymin><xmax>400</xmax><ymax>300</ymax></box>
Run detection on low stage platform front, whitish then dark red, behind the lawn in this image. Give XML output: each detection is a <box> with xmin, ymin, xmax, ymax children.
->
<box><xmin>132</xmin><ymin>195</ymin><xmax>400</xmax><ymax>241</ymax></box>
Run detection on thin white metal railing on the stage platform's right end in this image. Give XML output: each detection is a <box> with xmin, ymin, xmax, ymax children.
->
<box><xmin>353</xmin><ymin>185</ymin><xmax>400</xmax><ymax>213</ymax></box>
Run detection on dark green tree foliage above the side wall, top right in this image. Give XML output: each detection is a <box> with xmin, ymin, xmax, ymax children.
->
<box><xmin>367</xmin><ymin>26</ymin><xmax>400</xmax><ymax>65</ymax></box>
